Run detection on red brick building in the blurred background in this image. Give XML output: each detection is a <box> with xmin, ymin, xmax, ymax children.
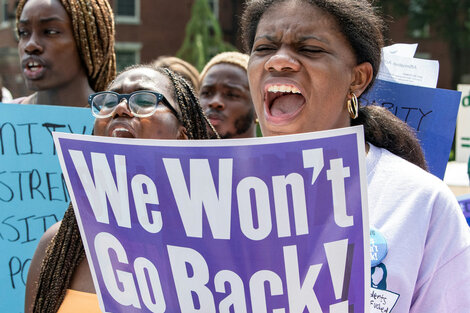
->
<box><xmin>0</xmin><ymin>0</ymin><xmax>470</xmax><ymax>96</ymax></box>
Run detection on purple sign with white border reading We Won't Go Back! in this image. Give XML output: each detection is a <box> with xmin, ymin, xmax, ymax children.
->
<box><xmin>54</xmin><ymin>127</ymin><xmax>370</xmax><ymax>313</ymax></box>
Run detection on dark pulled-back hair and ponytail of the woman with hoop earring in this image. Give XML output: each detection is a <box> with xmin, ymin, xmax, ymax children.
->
<box><xmin>241</xmin><ymin>0</ymin><xmax>427</xmax><ymax>169</ymax></box>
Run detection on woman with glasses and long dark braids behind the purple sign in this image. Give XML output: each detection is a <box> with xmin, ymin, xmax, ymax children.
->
<box><xmin>25</xmin><ymin>65</ymin><xmax>216</xmax><ymax>313</ymax></box>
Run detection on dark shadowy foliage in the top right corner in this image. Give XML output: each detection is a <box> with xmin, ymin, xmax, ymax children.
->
<box><xmin>378</xmin><ymin>0</ymin><xmax>470</xmax><ymax>87</ymax></box>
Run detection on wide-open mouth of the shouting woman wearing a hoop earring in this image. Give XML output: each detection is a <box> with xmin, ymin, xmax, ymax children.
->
<box><xmin>265</xmin><ymin>84</ymin><xmax>305</xmax><ymax>123</ymax></box>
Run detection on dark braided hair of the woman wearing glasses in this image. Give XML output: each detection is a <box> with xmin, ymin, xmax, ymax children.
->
<box><xmin>33</xmin><ymin>65</ymin><xmax>217</xmax><ymax>313</ymax></box>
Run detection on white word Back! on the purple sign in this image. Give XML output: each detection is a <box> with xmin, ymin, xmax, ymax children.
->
<box><xmin>162</xmin><ymin>244</ymin><xmax>348</xmax><ymax>313</ymax></box>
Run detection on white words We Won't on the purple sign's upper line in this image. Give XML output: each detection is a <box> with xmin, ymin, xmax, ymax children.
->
<box><xmin>69</xmin><ymin>149</ymin><xmax>354</xmax><ymax>241</ymax></box>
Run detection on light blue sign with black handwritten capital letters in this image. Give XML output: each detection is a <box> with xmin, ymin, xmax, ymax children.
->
<box><xmin>0</xmin><ymin>103</ymin><xmax>93</xmax><ymax>313</ymax></box>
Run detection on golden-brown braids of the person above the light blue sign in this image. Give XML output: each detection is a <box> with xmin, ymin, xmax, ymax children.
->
<box><xmin>16</xmin><ymin>0</ymin><xmax>116</xmax><ymax>91</ymax></box>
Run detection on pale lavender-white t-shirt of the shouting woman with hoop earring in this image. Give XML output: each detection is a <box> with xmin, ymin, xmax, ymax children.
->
<box><xmin>366</xmin><ymin>145</ymin><xmax>470</xmax><ymax>313</ymax></box>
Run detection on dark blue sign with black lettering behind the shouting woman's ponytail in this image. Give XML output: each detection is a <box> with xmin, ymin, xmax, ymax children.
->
<box><xmin>361</xmin><ymin>80</ymin><xmax>460</xmax><ymax>179</ymax></box>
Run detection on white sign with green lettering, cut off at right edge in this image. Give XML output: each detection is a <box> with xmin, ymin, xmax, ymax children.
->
<box><xmin>455</xmin><ymin>85</ymin><xmax>470</xmax><ymax>163</ymax></box>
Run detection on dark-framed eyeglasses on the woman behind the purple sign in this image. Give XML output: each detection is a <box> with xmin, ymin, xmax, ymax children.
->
<box><xmin>88</xmin><ymin>90</ymin><xmax>179</xmax><ymax>120</ymax></box>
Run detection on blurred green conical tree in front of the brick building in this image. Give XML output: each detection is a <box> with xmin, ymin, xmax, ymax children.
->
<box><xmin>176</xmin><ymin>0</ymin><xmax>235</xmax><ymax>71</ymax></box>
